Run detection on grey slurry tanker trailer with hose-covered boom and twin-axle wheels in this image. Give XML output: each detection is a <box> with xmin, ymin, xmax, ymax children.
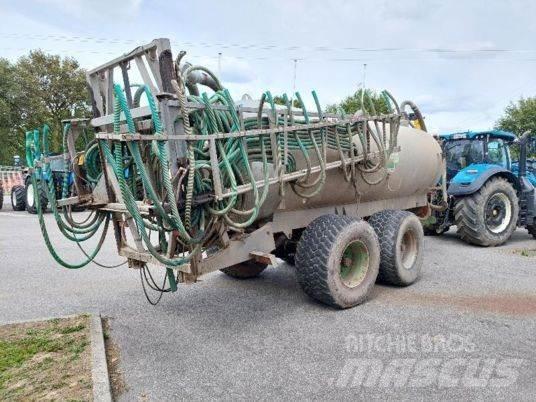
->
<box><xmin>27</xmin><ymin>39</ymin><xmax>444</xmax><ymax>308</ymax></box>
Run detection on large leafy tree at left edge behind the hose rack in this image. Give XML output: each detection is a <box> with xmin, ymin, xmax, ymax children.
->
<box><xmin>0</xmin><ymin>50</ymin><xmax>89</xmax><ymax>164</ymax></box>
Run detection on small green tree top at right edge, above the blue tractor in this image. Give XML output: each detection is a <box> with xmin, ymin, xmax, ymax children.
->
<box><xmin>495</xmin><ymin>97</ymin><xmax>536</xmax><ymax>135</ymax></box>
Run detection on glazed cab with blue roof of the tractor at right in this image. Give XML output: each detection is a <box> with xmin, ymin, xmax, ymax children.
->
<box><xmin>440</xmin><ymin>130</ymin><xmax>516</xmax><ymax>182</ymax></box>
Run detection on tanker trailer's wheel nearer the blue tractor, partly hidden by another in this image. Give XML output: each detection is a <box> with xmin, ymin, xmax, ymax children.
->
<box><xmin>368</xmin><ymin>210</ymin><xmax>424</xmax><ymax>286</ymax></box>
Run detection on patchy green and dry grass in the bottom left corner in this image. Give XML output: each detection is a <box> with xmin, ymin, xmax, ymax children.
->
<box><xmin>0</xmin><ymin>315</ymin><xmax>92</xmax><ymax>401</ymax></box>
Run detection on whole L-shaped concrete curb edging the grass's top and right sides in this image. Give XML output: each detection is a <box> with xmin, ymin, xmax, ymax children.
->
<box><xmin>0</xmin><ymin>313</ymin><xmax>112</xmax><ymax>402</ymax></box>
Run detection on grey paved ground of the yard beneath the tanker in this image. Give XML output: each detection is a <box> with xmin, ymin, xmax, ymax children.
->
<box><xmin>0</xmin><ymin>198</ymin><xmax>536</xmax><ymax>400</ymax></box>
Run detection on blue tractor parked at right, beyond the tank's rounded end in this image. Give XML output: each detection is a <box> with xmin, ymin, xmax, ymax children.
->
<box><xmin>424</xmin><ymin>130</ymin><xmax>536</xmax><ymax>246</ymax></box>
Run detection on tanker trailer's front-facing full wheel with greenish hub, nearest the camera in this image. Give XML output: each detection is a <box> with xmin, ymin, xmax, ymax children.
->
<box><xmin>296</xmin><ymin>215</ymin><xmax>380</xmax><ymax>308</ymax></box>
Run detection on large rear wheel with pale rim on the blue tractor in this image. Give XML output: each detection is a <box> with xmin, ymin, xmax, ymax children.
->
<box><xmin>454</xmin><ymin>177</ymin><xmax>519</xmax><ymax>247</ymax></box>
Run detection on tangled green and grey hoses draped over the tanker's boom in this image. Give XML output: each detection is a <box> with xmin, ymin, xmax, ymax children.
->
<box><xmin>27</xmin><ymin>66</ymin><xmax>397</xmax><ymax>268</ymax></box>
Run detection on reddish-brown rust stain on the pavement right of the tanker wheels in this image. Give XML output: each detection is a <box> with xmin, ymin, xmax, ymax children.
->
<box><xmin>371</xmin><ymin>286</ymin><xmax>536</xmax><ymax>317</ymax></box>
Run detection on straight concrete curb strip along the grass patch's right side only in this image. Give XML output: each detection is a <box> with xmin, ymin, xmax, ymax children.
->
<box><xmin>90</xmin><ymin>314</ymin><xmax>112</xmax><ymax>402</ymax></box>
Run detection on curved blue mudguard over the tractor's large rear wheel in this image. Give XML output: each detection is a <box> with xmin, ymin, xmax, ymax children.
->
<box><xmin>447</xmin><ymin>163</ymin><xmax>519</xmax><ymax>196</ymax></box>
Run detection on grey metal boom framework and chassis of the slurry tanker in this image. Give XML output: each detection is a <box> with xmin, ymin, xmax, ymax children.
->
<box><xmin>76</xmin><ymin>39</ymin><xmax>427</xmax><ymax>281</ymax></box>
